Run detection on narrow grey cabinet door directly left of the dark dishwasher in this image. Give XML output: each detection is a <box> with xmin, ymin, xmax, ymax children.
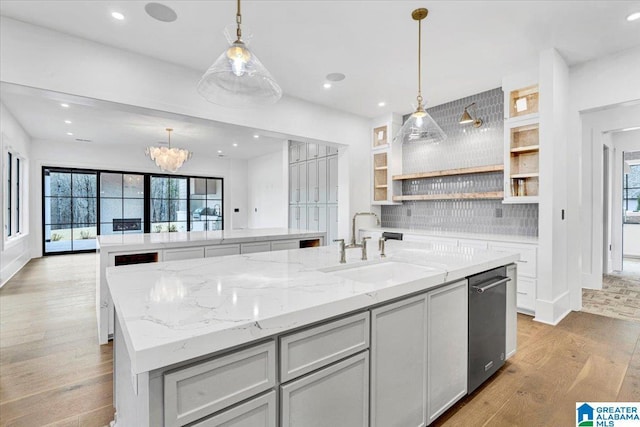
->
<box><xmin>427</xmin><ymin>280</ymin><xmax>469</xmax><ymax>424</ymax></box>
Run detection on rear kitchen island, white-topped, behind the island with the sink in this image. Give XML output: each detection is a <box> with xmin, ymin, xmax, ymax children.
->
<box><xmin>96</xmin><ymin>228</ymin><xmax>326</xmax><ymax>344</ymax></box>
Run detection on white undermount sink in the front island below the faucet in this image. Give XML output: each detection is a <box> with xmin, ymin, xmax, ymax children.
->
<box><xmin>321</xmin><ymin>261</ymin><xmax>442</xmax><ymax>284</ymax></box>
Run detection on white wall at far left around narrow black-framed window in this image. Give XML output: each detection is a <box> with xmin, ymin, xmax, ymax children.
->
<box><xmin>0</xmin><ymin>102</ymin><xmax>31</xmax><ymax>287</ymax></box>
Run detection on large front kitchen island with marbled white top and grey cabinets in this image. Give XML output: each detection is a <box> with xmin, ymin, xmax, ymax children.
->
<box><xmin>107</xmin><ymin>241</ymin><xmax>518</xmax><ymax>427</ymax></box>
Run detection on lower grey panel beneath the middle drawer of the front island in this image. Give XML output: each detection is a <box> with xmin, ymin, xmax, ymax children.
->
<box><xmin>280</xmin><ymin>351</ymin><xmax>369</xmax><ymax>427</ymax></box>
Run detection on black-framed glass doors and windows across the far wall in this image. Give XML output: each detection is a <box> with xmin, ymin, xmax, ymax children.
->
<box><xmin>42</xmin><ymin>167</ymin><xmax>224</xmax><ymax>254</ymax></box>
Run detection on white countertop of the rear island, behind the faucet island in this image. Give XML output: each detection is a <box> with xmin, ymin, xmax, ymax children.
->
<box><xmin>98</xmin><ymin>228</ymin><xmax>325</xmax><ymax>250</ymax></box>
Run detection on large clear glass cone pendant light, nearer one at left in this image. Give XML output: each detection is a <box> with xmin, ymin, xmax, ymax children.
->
<box><xmin>197</xmin><ymin>0</ymin><xmax>282</xmax><ymax>107</ymax></box>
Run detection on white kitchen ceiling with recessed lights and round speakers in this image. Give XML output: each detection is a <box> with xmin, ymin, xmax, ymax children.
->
<box><xmin>0</xmin><ymin>0</ymin><xmax>640</xmax><ymax>159</ymax></box>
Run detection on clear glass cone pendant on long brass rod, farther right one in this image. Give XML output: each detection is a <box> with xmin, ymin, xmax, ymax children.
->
<box><xmin>394</xmin><ymin>8</ymin><xmax>447</xmax><ymax>144</ymax></box>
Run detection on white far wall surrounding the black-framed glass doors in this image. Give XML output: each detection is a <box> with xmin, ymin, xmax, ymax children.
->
<box><xmin>30</xmin><ymin>140</ymin><xmax>248</xmax><ymax>257</ymax></box>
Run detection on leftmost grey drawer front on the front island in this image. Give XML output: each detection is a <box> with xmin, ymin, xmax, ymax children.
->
<box><xmin>164</xmin><ymin>341</ymin><xmax>277</xmax><ymax>427</ymax></box>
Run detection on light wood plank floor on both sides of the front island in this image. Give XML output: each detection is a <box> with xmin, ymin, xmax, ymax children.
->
<box><xmin>0</xmin><ymin>254</ymin><xmax>640</xmax><ymax>427</ymax></box>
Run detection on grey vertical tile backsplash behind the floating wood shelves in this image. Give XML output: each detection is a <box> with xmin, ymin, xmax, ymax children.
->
<box><xmin>381</xmin><ymin>88</ymin><xmax>538</xmax><ymax>236</ymax></box>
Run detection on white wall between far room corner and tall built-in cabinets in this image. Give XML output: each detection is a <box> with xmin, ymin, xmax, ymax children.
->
<box><xmin>247</xmin><ymin>140</ymin><xmax>289</xmax><ymax>228</ymax></box>
